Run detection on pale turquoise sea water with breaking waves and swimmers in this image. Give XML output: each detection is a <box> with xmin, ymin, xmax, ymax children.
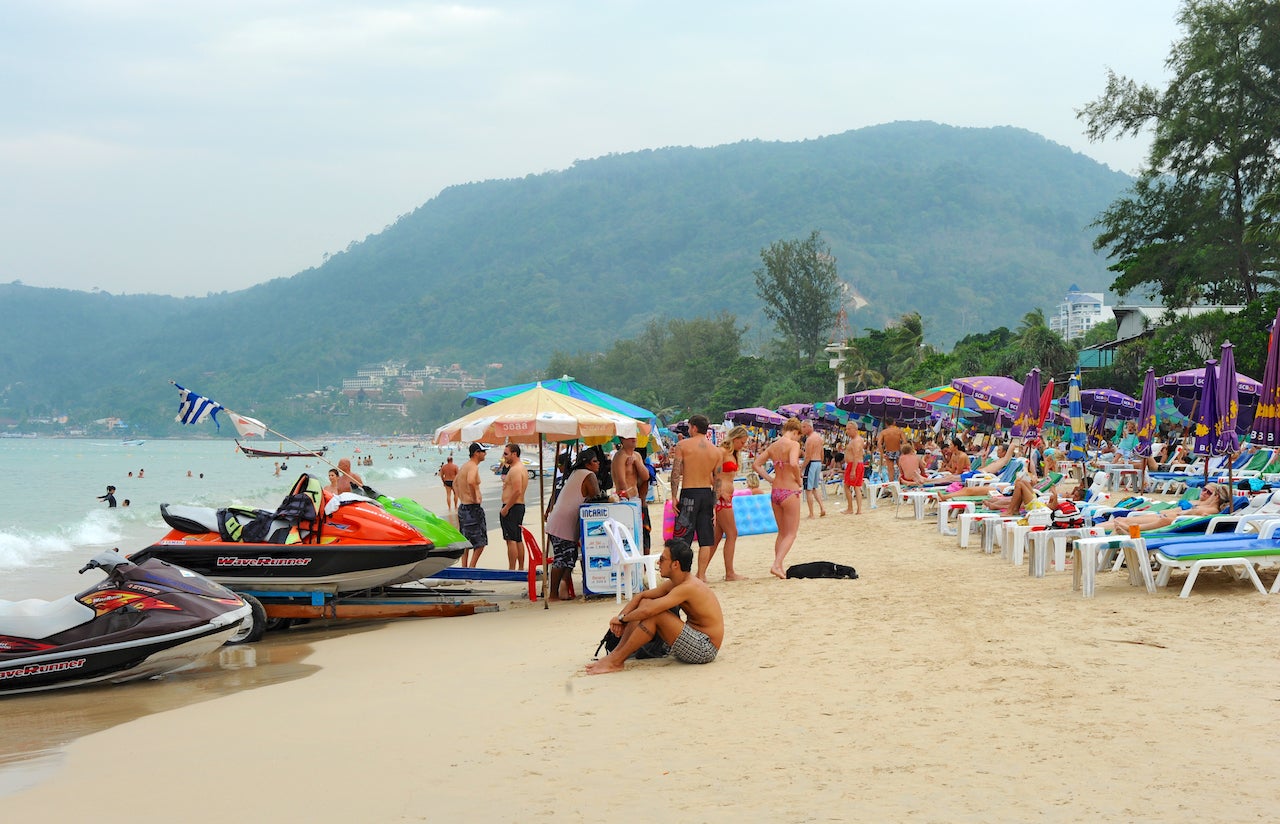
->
<box><xmin>0</xmin><ymin>436</ymin><xmax>460</xmax><ymax>600</ymax></box>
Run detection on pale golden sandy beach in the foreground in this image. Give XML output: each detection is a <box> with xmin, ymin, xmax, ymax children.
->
<box><xmin>0</xmin><ymin>486</ymin><xmax>1280</xmax><ymax>821</ymax></box>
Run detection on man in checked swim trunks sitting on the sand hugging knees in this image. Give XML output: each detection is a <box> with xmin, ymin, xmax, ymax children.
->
<box><xmin>586</xmin><ymin>539</ymin><xmax>724</xmax><ymax>676</ymax></box>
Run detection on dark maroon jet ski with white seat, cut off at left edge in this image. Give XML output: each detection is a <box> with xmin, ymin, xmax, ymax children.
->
<box><xmin>0</xmin><ymin>551</ymin><xmax>252</xmax><ymax>695</ymax></box>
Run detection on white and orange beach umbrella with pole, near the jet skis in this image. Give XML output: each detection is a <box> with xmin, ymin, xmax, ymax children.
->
<box><xmin>433</xmin><ymin>384</ymin><xmax>648</xmax><ymax>609</ymax></box>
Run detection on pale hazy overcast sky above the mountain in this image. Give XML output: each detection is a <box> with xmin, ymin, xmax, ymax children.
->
<box><xmin>0</xmin><ymin>0</ymin><xmax>1179</xmax><ymax>296</ymax></box>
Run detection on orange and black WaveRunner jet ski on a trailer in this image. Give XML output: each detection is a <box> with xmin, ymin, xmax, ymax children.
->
<box><xmin>132</xmin><ymin>473</ymin><xmax>462</xmax><ymax>595</ymax></box>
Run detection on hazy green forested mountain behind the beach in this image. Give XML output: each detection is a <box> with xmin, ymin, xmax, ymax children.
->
<box><xmin>0</xmin><ymin>123</ymin><xmax>1130</xmax><ymax>432</ymax></box>
